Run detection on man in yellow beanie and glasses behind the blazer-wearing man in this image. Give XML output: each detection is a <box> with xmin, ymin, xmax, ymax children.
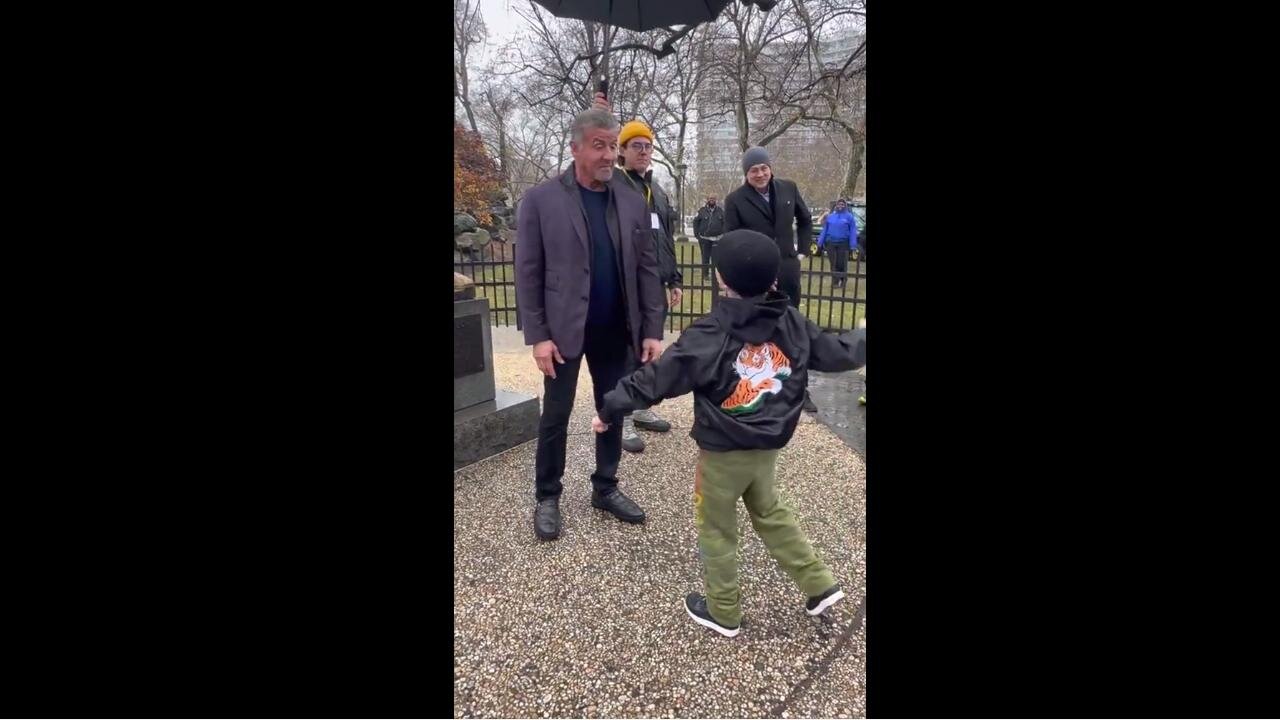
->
<box><xmin>617</xmin><ymin>120</ymin><xmax>684</xmax><ymax>452</ymax></box>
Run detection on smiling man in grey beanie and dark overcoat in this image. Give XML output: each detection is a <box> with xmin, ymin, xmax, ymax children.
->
<box><xmin>713</xmin><ymin>146</ymin><xmax>818</xmax><ymax>413</ymax></box>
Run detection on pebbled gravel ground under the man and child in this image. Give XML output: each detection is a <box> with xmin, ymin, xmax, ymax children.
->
<box><xmin>453</xmin><ymin>337</ymin><xmax>865</xmax><ymax>717</ymax></box>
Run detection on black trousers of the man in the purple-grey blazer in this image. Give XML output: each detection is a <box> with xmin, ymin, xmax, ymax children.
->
<box><xmin>534</xmin><ymin>325</ymin><xmax>635</xmax><ymax>500</ymax></box>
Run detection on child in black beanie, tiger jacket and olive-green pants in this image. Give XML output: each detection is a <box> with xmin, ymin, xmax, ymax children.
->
<box><xmin>591</xmin><ymin>229</ymin><xmax>867</xmax><ymax>637</ymax></box>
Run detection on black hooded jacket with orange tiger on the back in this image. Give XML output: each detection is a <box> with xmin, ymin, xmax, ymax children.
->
<box><xmin>600</xmin><ymin>289</ymin><xmax>867</xmax><ymax>452</ymax></box>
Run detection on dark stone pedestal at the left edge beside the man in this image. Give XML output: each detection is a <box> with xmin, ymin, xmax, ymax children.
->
<box><xmin>453</xmin><ymin>297</ymin><xmax>539</xmax><ymax>470</ymax></box>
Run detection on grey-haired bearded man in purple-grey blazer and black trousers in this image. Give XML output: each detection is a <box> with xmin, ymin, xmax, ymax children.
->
<box><xmin>516</xmin><ymin>108</ymin><xmax>666</xmax><ymax>539</ymax></box>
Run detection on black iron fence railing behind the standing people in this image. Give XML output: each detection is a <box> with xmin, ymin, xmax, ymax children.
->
<box><xmin>453</xmin><ymin>242</ymin><xmax>867</xmax><ymax>331</ymax></box>
